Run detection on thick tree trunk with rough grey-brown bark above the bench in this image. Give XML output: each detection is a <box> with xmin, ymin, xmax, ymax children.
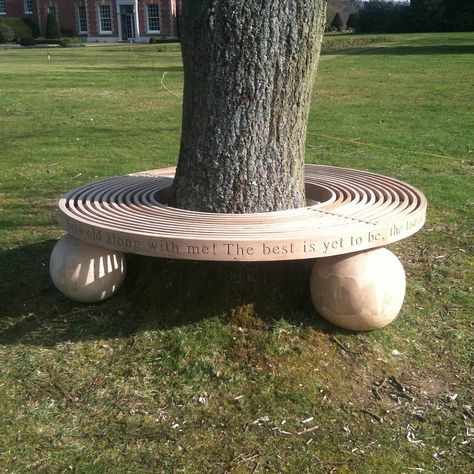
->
<box><xmin>171</xmin><ymin>0</ymin><xmax>326</xmax><ymax>213</ymax></box>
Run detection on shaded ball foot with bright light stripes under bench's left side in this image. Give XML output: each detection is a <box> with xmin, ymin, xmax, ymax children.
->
<box><xmin>49</xmin><ymin>235</ymin><xmax>126</xmax><ymax>303</ymax></box>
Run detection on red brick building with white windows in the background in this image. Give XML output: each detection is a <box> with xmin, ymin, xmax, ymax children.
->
<box><xmin>0</xmin><ymin>0</ymin><xmax>179</xmax><ymax>42</ymax></box>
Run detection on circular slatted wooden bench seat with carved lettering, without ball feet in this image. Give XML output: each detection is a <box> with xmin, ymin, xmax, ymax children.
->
<box><xmin>59</xmin><ymin>165</ymin><xmax>427</xmax><ymax>261</ymax></box>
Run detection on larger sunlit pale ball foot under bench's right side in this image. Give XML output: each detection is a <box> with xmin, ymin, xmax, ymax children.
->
<box><xmin>311</xmin><ymin>248</ymin><xmax>406</xmax><ymax>331</ymax></box>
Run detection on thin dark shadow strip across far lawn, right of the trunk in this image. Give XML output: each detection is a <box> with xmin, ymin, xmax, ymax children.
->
<box><xmin>336</xmin><ymin>44</ymin><xmax>474</xmax><ymax>56</ymax></box>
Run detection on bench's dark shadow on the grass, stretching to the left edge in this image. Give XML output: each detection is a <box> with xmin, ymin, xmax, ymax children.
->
<box><xmin>0</xmin><ymin>240</ymin><xmax>345</xmax><ymax>347</ymax></box>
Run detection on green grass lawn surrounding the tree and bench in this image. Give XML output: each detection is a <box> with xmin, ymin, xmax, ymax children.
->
<box><xmin>0</xmin><ymin>33</ymin><xmax>474</xmax><ymax>473</ymax></box>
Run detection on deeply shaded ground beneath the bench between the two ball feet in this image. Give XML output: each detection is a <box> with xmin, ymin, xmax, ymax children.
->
<box><xmin>127</xmin><ymin>255</ymin><xmax>314</xmax><ymax>326</ymax></box>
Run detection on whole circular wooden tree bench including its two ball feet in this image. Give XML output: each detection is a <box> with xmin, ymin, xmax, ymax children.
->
<box><xmin>51</xmin><ymin>165</ymin><xmax>426</xmax><ymax>330</ymax></box>
